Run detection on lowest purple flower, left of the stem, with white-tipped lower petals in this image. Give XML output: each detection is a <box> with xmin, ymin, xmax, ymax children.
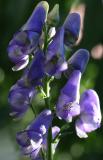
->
<box><xmin>16</xmin><ymin>109</ymin><xmax>53</xmax><ymax>159</ymax></box>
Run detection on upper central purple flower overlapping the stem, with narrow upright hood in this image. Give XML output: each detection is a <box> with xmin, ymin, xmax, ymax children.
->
<box><xmin>45</xmin><ymin>28</ymin><xmax>67</xmax><ymax>76</ymax></box>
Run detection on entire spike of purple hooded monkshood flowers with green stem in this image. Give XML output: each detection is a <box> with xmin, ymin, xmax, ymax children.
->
<box><xmin>8</xmin><ymin>1</ymin><xmax>101</xmax><ymax>160</ymax></box>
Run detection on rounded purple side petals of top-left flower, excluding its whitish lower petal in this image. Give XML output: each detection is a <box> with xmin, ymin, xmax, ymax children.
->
<box><xmin>8</xmin><ymin>31</ymin><xmax>39</xmax><ymax>64</ymax></box>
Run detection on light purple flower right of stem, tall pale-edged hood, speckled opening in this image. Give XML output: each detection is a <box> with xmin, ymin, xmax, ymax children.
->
<box><xmin>56</xmin><ymin>70</ymin><xmax>81</xmax><ymax>122</ymax></box>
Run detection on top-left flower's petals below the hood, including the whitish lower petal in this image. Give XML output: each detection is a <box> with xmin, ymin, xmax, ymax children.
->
<box><xmin>8</xmin><ymin>31</ymin><xmax>39</xmax><ymax>71</ymax></box>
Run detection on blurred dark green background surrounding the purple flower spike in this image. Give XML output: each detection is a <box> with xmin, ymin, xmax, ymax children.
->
<box><xmin>0</xmin><ymin>0</ymin><xmax>103</xmax><ymax>160</ymax></box>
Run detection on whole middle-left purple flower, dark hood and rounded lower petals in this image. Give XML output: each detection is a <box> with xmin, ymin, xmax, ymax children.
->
<box><xmin>9</xmin><ymin>51</ymin><xmax>44</xmax><ymax>118</ymax></box>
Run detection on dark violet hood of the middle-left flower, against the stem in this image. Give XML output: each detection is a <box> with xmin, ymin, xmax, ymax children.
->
<box><xmin>18</xmin><ymin>50</ymin><xmax>45</xmax><ymax>87</ymax></box>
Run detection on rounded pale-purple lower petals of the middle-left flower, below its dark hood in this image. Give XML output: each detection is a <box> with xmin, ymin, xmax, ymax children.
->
<box><xmin>8</xmin><ymin>84</ymin><xmax>36</xmax><ymax>118</ymax></box>
